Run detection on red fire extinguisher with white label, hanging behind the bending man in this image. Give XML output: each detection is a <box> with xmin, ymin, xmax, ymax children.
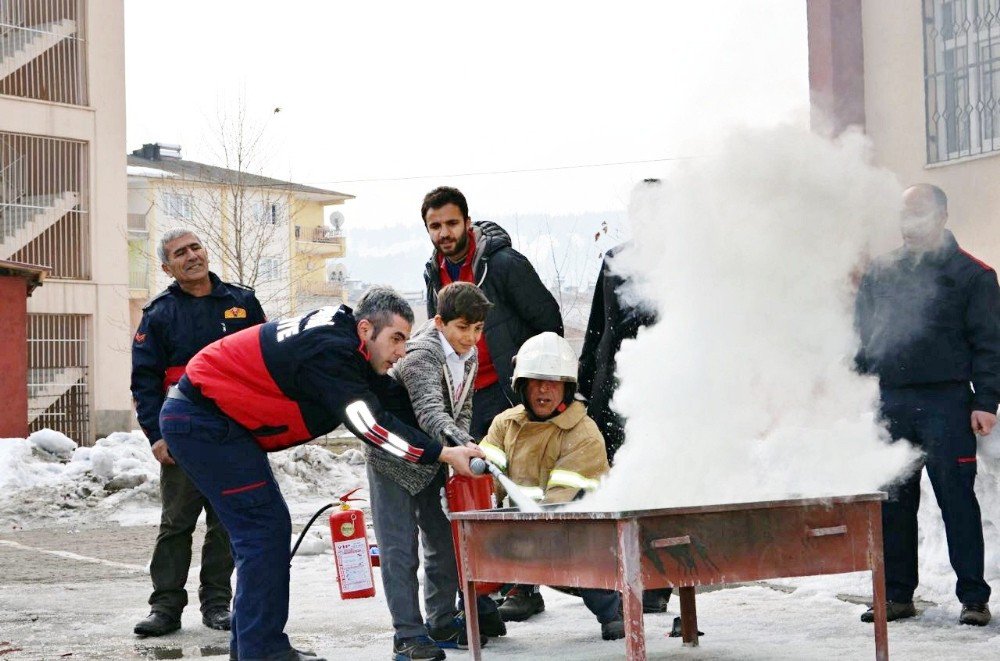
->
<box><xmin>330</xmin><ymin>487</ymin><xmax>375</xmax><ymax>599</ymax></box>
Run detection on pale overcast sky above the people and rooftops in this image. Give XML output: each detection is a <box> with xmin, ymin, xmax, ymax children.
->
<box><xmin>125</xmin><ymin>0</ymin><xmax>808</xmax><ymax>235</ymax></box>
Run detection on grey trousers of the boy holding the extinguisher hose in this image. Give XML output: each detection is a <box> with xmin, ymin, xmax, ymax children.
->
<box><xmin>368</xmin><ymin>465</ymin><xmax>458</xmax><ymax>639</ymax></box>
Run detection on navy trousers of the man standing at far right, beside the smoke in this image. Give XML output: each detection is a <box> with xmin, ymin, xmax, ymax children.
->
<box><xmin>882</xmin><ymin>383</ymin><xmax>990</xmax><ymax>603</ymax></box>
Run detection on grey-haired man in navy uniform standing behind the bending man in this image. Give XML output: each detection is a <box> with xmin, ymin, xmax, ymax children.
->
<box><xmin>131</xmin><ymin>228</ymin><xmax>266</xmax><ymax>636</ymax></box>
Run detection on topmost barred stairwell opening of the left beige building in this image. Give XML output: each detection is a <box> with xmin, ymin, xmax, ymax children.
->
<box><xmin>0</xmin><ymin>0</ymin><xmax>87</xmax><ymax>105</ymax></box>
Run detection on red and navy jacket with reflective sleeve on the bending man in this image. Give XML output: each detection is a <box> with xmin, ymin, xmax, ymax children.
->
<box><xmin>178</xmin><ymin>305</ymin><xmax>441</xmax><ymax>464</ymax></box>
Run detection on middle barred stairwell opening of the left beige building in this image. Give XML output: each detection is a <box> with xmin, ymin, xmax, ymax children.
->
<box><xmin>0</xmin><ymin>132</ymin><xmax>90</xmax><ymax>280</ymax></box>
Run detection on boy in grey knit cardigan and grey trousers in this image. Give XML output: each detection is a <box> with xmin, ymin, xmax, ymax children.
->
<box><xmin>365</xmin><ymin>282</ymin><xmax>506</xmax><ymax>661</ymax></box>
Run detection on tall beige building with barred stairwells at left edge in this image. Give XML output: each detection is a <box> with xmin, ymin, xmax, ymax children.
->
<box><xmin>0</xmin><ymin>0</ymin><xmax>131</xmax><ymax>443</ymax></box>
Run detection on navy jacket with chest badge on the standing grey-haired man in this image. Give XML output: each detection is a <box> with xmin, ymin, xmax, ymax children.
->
<box><xmin>132</xmin><ymin>273</ymin><xmax>267</xmax><ymax>443</ymax></box>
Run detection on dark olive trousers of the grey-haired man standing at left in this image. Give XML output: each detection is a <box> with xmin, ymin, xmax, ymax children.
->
<box><xmin>149</xmin><ymin>466</ymin><xmax>233</xmax><ymax>617</ymax></box>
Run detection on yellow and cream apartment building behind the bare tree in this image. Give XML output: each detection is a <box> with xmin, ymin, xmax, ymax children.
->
<box><xmin>128</xmin><ymin>143</ymin><xmax>353</xmax><ymax>328</ymax></box>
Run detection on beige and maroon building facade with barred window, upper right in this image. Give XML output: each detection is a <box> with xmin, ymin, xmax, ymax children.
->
<box><xmin>808</xmin><ymin>0</ymin><xmax>1000</xmax><ymax>266</ymax></box>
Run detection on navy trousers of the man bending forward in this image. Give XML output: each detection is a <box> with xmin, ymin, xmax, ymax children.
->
<box><xmin>160</xmin><ymin>397</ymin><xmax>292</xmax><ymax>659</ymax></box>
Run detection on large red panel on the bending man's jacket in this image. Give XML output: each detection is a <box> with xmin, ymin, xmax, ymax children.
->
<box><xmin>187</xmin><ymin>326</ymin><xmax>313</xmax><ymax>452</ymax></box>
